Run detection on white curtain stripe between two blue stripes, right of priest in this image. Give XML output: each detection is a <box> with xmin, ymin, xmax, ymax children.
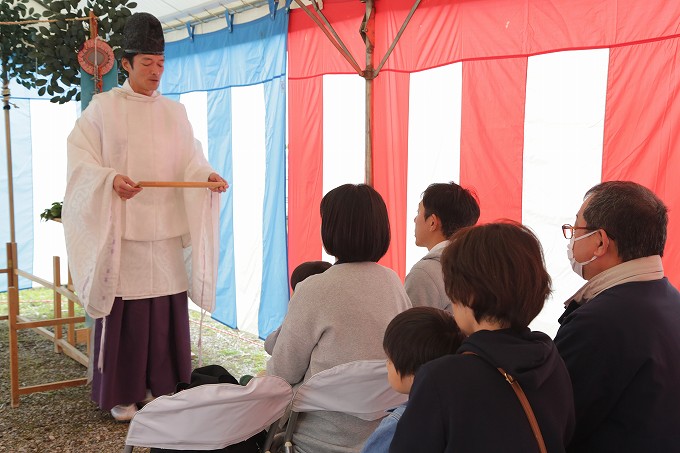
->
<box><xmin>229</xmin><ymin>84</ymin><xmax>266</xmax><ymax>332</ymax></box>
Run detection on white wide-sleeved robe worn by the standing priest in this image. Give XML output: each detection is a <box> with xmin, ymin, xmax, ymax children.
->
<box><xmin>62</xmin><ymin>82</ymin><xmax>219</xmax><ymax>318</ymax></box>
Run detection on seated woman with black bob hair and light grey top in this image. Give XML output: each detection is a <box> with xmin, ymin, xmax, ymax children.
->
<box><xmin>267</xmin><ymin>184</ymin><xmax>411</xmax><ymax>453</ymax></box>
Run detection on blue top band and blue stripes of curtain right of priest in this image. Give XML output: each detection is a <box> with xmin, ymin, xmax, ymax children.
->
<box><xmin>160</xmin><ymin>11</ymin><xmax>289</xmax><ymax>337</ymax></box>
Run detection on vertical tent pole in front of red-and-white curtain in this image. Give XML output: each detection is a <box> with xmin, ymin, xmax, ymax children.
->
<box><xmin>360</xmin><ymin>0</ymin><xmax>375</xmax><ymax>186</ymax></box>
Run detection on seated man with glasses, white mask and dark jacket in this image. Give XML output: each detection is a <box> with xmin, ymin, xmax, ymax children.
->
<box><xmin>555</xmin><ymin>181</ymin><xmax>680</xmax><ymax>453</ymax></box>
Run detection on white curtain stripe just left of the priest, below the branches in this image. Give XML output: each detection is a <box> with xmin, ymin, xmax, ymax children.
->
<box><xmin>30</xmin><ymin>100</ymin><xmax>79</xmax><ymax>282</ymax></box>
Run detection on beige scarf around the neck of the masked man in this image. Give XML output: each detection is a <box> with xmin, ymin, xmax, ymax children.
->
<box><xmin>564</xmin><ymin>255</ymin><xmax>664</xmax><ymax>307</ymax></box>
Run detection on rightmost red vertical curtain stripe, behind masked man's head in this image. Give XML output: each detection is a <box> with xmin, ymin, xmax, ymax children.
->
<box><xmin>602</xmin><ymin>39</ymin><xmax>680</xmax><ymax>285</ymax></box>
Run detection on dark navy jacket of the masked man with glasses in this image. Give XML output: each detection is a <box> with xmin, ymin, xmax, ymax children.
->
<box><xmin>555</xmin><ymin>278</ymin><xmax>680</xmax><ymax>453</ymax></box>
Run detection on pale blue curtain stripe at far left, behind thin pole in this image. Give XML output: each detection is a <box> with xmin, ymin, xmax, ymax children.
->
<box><xmin>0</xmin><ymin>98</ymin><xmax>34</xmax><ymax>291</ymax></box>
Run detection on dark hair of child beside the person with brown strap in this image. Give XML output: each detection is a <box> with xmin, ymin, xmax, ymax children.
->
<box><xmin>383</xmin><ymin>307</ymin><xmax>465</xmax><ymax>376</ymax></box>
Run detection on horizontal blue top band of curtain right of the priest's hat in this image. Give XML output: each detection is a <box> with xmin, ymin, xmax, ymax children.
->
<box><xmin>160</xmin><ymin>11</ymin><xmax>288</xmax><ymax>94</ymax></box>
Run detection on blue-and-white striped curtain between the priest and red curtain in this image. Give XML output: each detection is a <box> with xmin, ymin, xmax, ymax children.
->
<box><xmin>161</xmin><ymin>10</ymin><xmax>289</xmax><ymax>338</ymax></box>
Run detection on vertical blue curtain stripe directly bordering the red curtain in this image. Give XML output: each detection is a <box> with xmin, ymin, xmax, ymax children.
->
<box><xmin>258</xmin><ymin>78</ymin><xmax>289</xmax><ymax>338</ymax></box>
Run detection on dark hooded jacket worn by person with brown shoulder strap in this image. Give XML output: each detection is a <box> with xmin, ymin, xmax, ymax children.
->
<box><xmin>390</xmin><ymin>329</ymin><xmax>574</xmax><ymax>453</ymax></box>
